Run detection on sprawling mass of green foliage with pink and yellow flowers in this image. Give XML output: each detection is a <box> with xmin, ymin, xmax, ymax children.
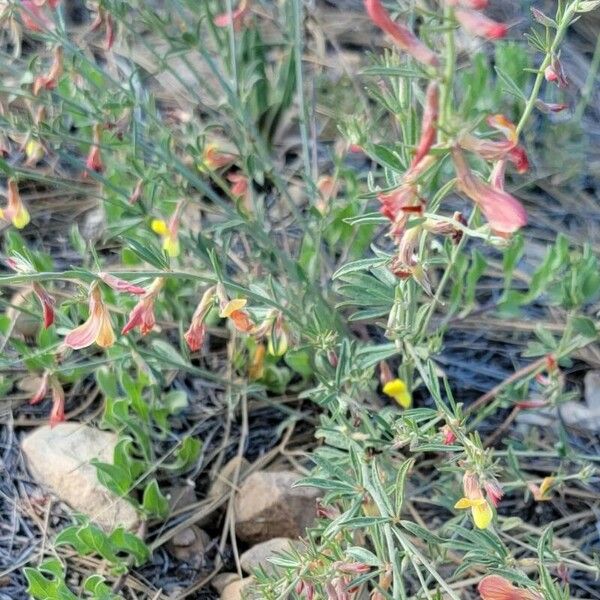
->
<box><xmin>0</xmin><ymin>0</ymin><xmax>600</xmax><ymax>600</ymax></box>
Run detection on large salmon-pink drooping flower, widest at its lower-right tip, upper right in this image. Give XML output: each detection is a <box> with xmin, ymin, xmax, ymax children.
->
<box><xmin>452</xmin><ymin>148</ymin><xmax>527</xmax><ymax>235</ymax></box>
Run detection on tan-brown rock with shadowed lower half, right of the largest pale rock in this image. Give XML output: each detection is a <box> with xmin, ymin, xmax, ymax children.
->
<box><xmin>235</xmin><ymin>471</ymin><xmax>319</xmax><ymax>544</ymax></box>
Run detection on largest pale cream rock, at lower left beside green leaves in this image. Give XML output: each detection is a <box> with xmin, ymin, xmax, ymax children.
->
<box><xmin>21</xmin><ymin>422</ymin><xmax>139</xmax><ymax>531</ymax></box>
